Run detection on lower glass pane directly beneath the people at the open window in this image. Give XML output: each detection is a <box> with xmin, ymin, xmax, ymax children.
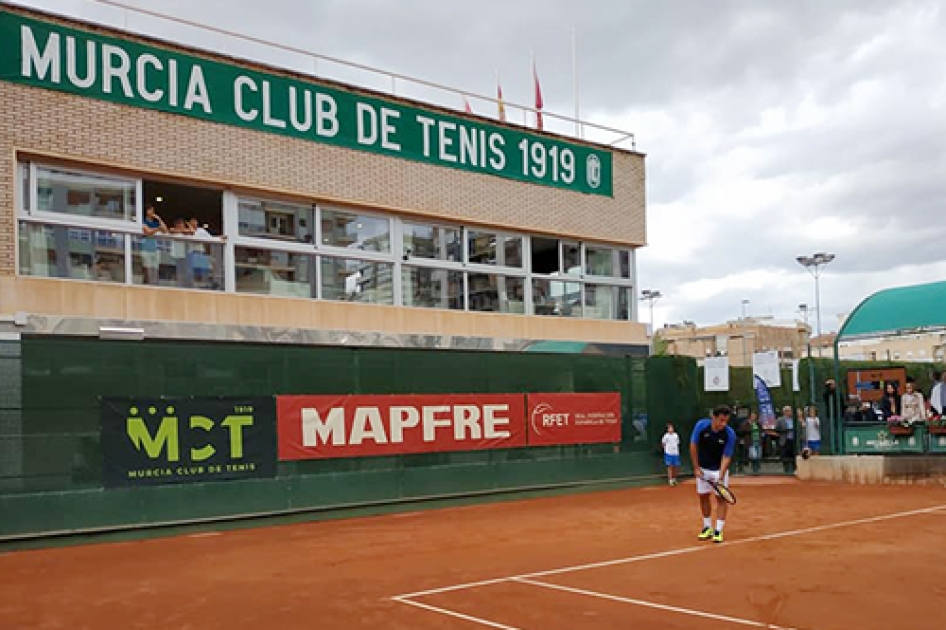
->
<box><xmin>131</xmin><ymin>234</ymin><xmax>224</xmax><ymax>291</ymax></box>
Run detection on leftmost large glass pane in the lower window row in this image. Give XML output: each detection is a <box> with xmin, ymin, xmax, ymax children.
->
<box><xmin>19</xmin><ymin>221</ymin><xmax>125</xmax><ymax>282</ymax></box>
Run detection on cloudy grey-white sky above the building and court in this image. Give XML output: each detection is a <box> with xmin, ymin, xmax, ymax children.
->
<box><xmin>12</xmin><ymin>0</ymin><xmax>946</xmax><ymax>331</ymax></box>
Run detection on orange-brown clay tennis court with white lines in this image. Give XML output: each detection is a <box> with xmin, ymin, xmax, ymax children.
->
<box><xmin>0</xmin><ymin>479</ymin><xmax>946</xmax><ymax>630</ymax></box>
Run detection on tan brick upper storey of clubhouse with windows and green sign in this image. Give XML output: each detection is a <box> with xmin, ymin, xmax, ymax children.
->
<box><xmin>0</xmin><ymin>8</ymin><xmax>647</xmax><ymax>353</ymax></box>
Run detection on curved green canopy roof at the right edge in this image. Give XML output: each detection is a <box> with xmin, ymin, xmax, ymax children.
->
<box><xmin>838</xmin><ymin>282</ymin><xmax>946</xmax><ymax>340</ymax></box>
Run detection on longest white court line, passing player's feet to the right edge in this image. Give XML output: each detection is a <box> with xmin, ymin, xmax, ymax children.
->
<box><xmin>392</xmin><ymin>505</ymin><xmax>946</xmax><ymax>603</ymax></box>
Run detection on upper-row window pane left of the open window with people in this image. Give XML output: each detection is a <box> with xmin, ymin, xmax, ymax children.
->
<box><xmin>36</xmin><ymin>167</ymin><xmax>137</xmax><ymax>221</ymax></box>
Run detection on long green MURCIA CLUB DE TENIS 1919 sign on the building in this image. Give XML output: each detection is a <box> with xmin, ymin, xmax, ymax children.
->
<box><xmin>0</xmin><ymin>11</ymin><xmax>613</xmax><ymax>196</ymax></box>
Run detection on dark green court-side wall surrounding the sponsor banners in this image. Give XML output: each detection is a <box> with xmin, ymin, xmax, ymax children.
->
<box><xmin>0</xmin><ymin>336</ymin><xmax>662</xmax><ymax>537</ymax></box>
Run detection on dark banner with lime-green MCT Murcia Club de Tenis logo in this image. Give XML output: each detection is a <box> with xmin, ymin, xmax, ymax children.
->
<box><xmin>102</xmin><ymin>397</ymin><xmax>276</xmax><ymax>487</ymax></box>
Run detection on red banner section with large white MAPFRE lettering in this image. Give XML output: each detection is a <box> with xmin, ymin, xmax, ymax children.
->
<box><xmin>276</xmin><ymin>394</ymin><xmax>526</xmax><ymax>461</ymax></box>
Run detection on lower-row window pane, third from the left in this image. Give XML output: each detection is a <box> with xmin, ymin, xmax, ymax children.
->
<box><xmin>235</xmin><ymin>247</ymin><xmax>316</xmax><ymax>298</ymax></box>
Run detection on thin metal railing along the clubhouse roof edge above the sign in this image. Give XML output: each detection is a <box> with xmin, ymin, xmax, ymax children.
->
<box><xmin>0</xmin><ymin>0</ymin><xmax>637</xmax><ymax>151</ymax></box>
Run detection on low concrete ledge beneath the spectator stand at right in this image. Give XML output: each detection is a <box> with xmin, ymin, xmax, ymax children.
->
<box><xmin>796</xmin><ymin>455</ymin><xmax>946</xmax><ymax>484</ymax></box>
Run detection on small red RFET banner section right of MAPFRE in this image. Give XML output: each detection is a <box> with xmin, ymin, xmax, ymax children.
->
<box><xmin>529</xmin><ymin>392</ymin><xmax>621</xmax><ymax>446</ymax></box>
